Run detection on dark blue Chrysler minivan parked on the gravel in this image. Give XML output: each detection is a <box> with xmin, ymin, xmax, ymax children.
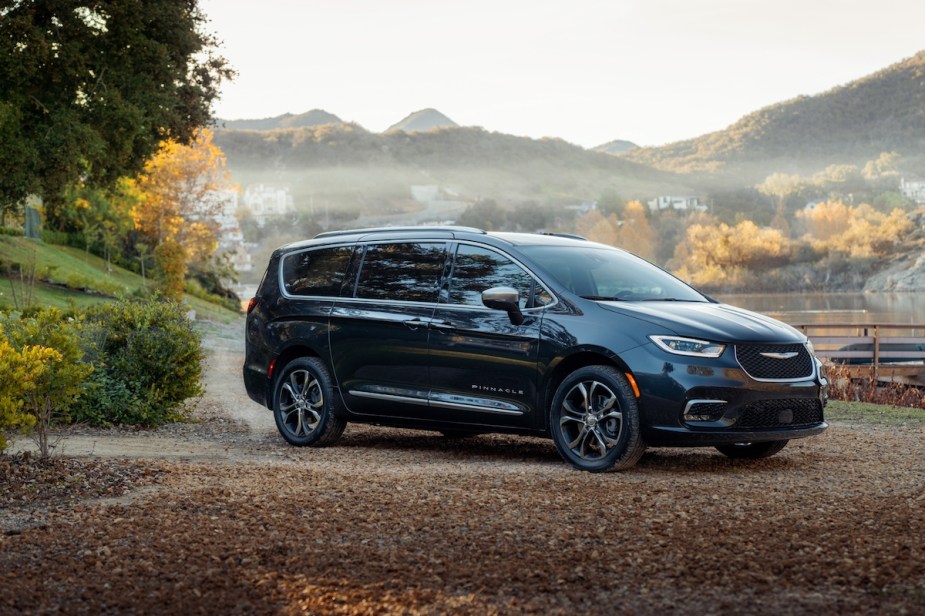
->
<box><xmin>244</xmin><ymin>227</ymin><xmax>827</xmax><ymax>471</ymax></box>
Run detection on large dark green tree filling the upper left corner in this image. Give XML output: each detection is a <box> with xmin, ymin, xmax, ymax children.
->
<box><xmin>0</xmin><ymin>0</ymin><xmax>233</xmax><ymax>229</ymax></box>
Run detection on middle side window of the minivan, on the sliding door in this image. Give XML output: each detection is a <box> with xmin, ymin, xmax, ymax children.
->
<box><xmin>356</xmin><ymin>242</ymin><xmax>446</xmax><ymax>302</ymax></box>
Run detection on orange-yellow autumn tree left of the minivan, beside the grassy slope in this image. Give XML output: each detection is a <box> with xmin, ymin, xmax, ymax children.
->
<box><xmin>132</xmin><ymin>129</ymin><xmax>234</xmax><ymax>299</ymax></box>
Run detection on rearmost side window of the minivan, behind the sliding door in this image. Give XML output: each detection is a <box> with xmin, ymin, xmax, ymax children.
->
<box><xmin>283</xmin><ymin>246</ymin><xmax>353</xmax><ymax>297</ymax></box>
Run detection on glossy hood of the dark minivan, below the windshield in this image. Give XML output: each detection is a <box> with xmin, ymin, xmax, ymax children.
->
<box><xmin>598</xmin><ymin>301</ymin><xmax>806</xmax><ymax>343</ymax></box>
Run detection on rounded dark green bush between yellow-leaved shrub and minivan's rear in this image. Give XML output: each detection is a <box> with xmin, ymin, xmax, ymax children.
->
<box><xmin>74</xmin><ymin>298</ymin><xmax>203</xmax><ymax>427</ymax></box>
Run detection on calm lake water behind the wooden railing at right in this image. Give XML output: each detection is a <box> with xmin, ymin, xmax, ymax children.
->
<box><xmin>715</xmin><ymin>293</ymin><xmax>925</xmax><ymax>325</ymax></box>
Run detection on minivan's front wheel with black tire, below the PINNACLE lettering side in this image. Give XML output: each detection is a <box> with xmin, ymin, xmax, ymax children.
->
<box><xmin>549</xmin><ymin>366</ymin><xmax>646</xmax><ymax>472</ymax></box>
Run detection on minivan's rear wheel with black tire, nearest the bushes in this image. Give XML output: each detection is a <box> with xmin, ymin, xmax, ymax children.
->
<box><xmin>273</xmin><ymin>357</ymin><xmax>347</xmax><ymax>447</ymax></box>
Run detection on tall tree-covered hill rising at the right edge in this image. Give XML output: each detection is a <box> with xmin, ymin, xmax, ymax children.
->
<box><xmin>622</xmin><ymin>51</ymin><xmax>925</xmax><ymax>181</ymax></box>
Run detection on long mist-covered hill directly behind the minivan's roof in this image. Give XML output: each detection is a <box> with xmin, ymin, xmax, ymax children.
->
<box><xmin>215</xmin><ymin>124</ymin><xmax>688</xmax><ymax>224</ymax></box>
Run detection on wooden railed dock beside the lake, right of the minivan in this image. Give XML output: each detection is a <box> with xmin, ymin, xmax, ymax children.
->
<box><xmin>794</xmin><ymin>323</ymin><xmax>925</xmax><ymax>386</ymax></box>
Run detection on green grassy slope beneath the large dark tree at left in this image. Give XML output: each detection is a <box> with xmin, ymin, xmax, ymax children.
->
<box><xmin>0</xmin><ymin>236</ymin><xmax>238</xmax><ymax>322</ymax></box>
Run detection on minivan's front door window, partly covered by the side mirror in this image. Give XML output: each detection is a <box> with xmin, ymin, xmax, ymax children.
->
<box><xmin>449</xmin><ymin>244</ymin><xmax>534</xmax><ymax>308</ymax></box>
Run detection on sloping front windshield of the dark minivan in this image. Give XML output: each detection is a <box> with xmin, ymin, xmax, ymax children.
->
<box><xmin>521</xmin><ymin>244</ymin><xmax>709</xmax><ymax>302</ymax></box>
